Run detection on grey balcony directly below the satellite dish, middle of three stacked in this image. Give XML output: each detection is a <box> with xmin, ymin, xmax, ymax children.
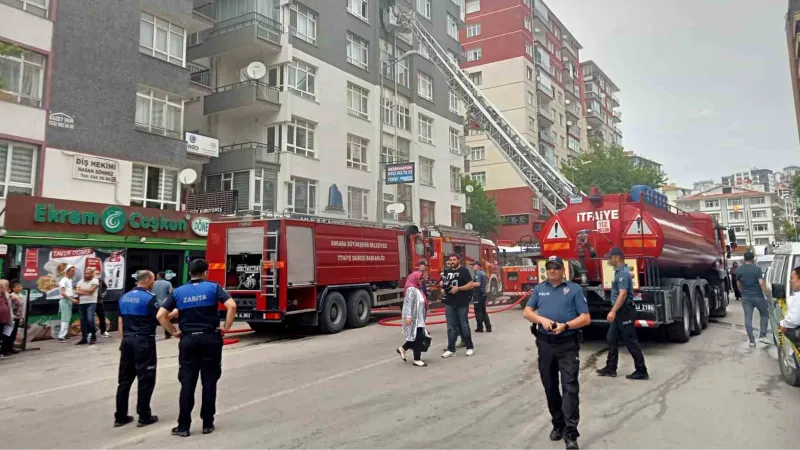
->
<box><xmin>203</xmin><ymin>80</ymin><xmax>281</xmax><ymax>117</ymax></box>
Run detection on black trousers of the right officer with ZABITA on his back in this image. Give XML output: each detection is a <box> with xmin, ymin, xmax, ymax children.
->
<box><xmin>178</xmin><ymin>332</ymin><xmax>222</xmax><ymax>430</ymax></box>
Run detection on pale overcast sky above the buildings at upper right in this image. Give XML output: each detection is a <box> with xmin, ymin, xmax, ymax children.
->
<box><xmin>545</xmin><ymin>0</ymin><xmax>800</xmax><ymax>188</ymax></box>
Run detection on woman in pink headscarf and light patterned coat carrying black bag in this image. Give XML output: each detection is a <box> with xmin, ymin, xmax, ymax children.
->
<box><xmin>397</xmin><ymin>272</ymin><xmax>430</xmax><ymax>367</ymax></box>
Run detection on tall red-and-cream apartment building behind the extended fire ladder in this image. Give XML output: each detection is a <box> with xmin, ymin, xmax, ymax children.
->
<box><xmin>460</xmin><ymin>0</ymin><xmax>587</xmax><ymax>241</ymax></box>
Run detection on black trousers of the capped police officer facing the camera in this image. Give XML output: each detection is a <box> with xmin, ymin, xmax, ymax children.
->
<box><xmin>536</xmin><ymin>333</ymin><xmax>580</xmax><ymax>438</ymax></box>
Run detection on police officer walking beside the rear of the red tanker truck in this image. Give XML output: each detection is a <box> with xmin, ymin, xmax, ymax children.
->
<box><xmin>597</xmin><ymin>247</ymin><xmax>650</xmax><ymax>380</ymax></box>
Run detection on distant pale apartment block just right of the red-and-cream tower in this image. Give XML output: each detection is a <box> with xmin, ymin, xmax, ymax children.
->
<box><xmin>581</xmin><ymin>61</ymin><xmax>622</xmax><ymax>147</ymax></box>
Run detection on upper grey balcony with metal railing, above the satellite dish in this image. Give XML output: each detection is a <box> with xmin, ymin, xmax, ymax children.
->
<box><xmin>186</xmin><ymin>13</ymin><xmax>283</xmax><ymax>61</ymax></box>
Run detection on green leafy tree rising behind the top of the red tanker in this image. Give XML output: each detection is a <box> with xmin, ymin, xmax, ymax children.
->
<box><xmin>561</xmin><ymin>140</ymin><xmax>667</xmax><ymax>194</ymax></box>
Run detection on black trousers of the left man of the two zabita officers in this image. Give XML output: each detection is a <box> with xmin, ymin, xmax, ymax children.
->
<box><xmin>114</xmin><ymin>335</ymin><xmax>158</xmax><ymax>420</ymax></box>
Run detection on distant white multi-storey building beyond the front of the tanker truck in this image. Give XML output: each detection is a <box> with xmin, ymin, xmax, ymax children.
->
<box><xmin>676</xmin><ymin>185</ymin><xmax>785</xmax><ymax>250</ymax></box>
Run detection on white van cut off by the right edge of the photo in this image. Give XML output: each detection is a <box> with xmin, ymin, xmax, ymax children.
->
<box><xmin>767</xmin><ymin>242</ymin><xmax>800</xmax><ymax>387</ymax></box>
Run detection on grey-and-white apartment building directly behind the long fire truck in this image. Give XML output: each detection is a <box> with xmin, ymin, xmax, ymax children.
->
<box><xmin>185</xmin><ymin>0</ymin><xmax>465</xmax><ymax>226</ymax></box>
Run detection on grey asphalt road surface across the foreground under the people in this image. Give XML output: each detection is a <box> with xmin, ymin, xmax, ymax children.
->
<box><xmin>0</xmin><ymin>298</ymin><xmax>800</xmax><ymax>450</ymax></box>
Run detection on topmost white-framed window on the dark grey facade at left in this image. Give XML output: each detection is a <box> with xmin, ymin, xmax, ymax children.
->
<box><xmin>139</xmin><ymin>13</ymin><xmax>186</xmax><ymax>67</ymax></box>
